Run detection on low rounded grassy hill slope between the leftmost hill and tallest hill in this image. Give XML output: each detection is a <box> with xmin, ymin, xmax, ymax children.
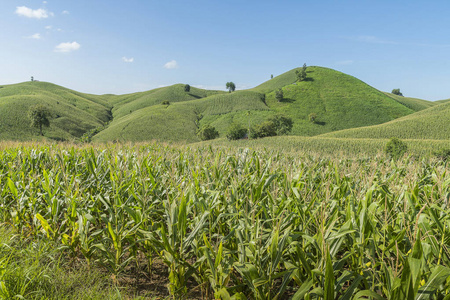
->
<box><xmin>94</xmin><ymin>91</ymin><xmax>267</xmax><ymax>142</ymax></box>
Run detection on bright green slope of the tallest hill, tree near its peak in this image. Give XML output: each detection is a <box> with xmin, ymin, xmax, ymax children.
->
<box><xmin>253</xmin><ymin>67</ymin><xmax>414</xmax><ymax>136</ymax></box>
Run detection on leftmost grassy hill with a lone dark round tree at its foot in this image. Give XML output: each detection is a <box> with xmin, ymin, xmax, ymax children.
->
<box><xmin>0</xmin><ymin>82</ymin><xmax>111</xmax><ymax>140</ymax></box>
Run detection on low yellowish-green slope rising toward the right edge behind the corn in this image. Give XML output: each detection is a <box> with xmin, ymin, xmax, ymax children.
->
<box><xmin>323</xmin><ymin>103</ymin><xmax>450</xmax><ymax>140</ymax></box>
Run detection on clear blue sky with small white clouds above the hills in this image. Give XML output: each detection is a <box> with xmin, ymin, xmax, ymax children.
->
<box><xmin>0</xmin><ymin>0</ymin><xmax>450</xmax><ymax>100</ymax></box>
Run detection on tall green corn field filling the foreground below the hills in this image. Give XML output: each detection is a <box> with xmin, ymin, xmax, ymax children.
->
<box><xmin>0</xmin><ymin>144</ymin><xmax>450</xmax><ymax>300</ymax></box>
